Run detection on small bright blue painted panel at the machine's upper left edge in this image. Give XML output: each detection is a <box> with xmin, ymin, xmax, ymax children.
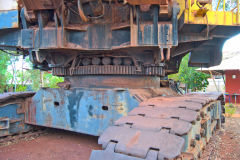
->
<box><xmin>0</xmin><ymin>10</ymin><xmax>19</xmax><ymax>29</ymax></box>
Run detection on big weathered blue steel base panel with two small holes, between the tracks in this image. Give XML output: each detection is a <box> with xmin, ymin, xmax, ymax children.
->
<box><xmin>26</xmin><ymin>89</ymin><xmax>139</xmax><ymax>136</ymax></box>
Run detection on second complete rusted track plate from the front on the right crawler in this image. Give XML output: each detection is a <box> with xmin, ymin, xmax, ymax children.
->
<box><xmin>115</xmin><ymin>116</ymin><xmax>192</xmax><ymax>135</ymax></box>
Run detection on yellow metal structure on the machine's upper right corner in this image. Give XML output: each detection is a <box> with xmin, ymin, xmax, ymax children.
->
<box><xmin>178</xmin><ymin>0</ymin><xmax>240</xmax><ymax>26</ymax></box>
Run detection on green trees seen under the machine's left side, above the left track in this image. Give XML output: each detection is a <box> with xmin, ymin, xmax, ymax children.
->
<box><xmin>0</xmin><ymin>52</ymin><xmax>64</xmax><ymax>93</ymax></box>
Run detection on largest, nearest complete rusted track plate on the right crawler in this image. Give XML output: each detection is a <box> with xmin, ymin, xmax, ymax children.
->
<box><xmin>98</xmin><ymin>126</ymin><xmax>184</xmax><ymax>159</ymax></box>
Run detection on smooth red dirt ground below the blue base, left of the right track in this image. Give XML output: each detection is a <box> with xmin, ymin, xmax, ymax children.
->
<box><xmin>0</xmin><ymin>130</ymin><xmax>101</xmax><ymax>160</ymax></box>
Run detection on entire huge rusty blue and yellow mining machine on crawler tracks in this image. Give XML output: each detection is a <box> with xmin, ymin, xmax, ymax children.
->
<box><xmin>0</xmin><ymin>0</ymin><xmax>240</xmax><ymax>160</ymax></box>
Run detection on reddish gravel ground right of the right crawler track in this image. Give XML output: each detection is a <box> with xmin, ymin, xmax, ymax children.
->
<box><xmin>202</xmin><ymin>108</ymin><xmax>240</xmax><ymax>160</ymax></box>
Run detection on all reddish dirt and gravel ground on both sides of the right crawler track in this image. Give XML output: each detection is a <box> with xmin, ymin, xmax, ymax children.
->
<box><xmin>0</xmin><ymin>109</ymin><xmax>240</xmax><ymax>160</ymax></box>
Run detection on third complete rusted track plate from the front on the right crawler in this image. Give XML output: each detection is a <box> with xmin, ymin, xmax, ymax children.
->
<box><xmin>129</xmin><ymin>107</ymin><xmax>198</xmax><ymax>122</ymax></box>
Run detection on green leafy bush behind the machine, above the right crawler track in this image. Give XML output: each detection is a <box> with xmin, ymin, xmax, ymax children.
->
<box><xmin>169</xmin><ymin>54</ymin><xmax>210</xmax><ymax>91</ymax></box>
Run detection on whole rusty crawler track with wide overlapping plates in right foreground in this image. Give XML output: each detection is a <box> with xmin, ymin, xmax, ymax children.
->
<box><xmin>90</xmin><ymin>93</ymin><xmax>223</xmax><ymax>160</ymax></box>
